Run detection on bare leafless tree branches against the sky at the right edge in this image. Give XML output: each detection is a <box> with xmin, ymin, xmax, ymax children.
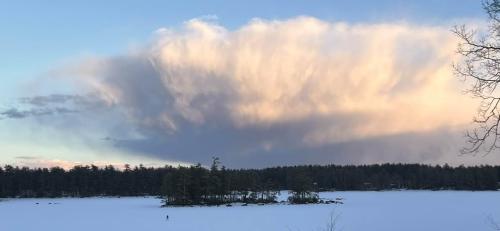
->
<box><xmin>453</xmin><ymin>0</ymin><xmax>500</xmax><ymax>154</ymax></box>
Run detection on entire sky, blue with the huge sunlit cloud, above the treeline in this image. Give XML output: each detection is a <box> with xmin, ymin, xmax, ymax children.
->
<box><xmin>0</xmin><ymin>0</ymin><xmax>494</xmax><ymax>168</ymax></box>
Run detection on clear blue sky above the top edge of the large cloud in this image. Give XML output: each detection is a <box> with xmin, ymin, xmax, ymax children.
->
<box><xmin>0</xmin><ymin>0</ymin><xmax>484</xmax><ymax>91</ymax></box>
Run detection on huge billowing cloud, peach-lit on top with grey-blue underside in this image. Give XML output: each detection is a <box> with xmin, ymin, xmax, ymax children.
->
<box><xmin>51</xmin><ymin>17</ymin><xmax>484</xmax><ymax>166</ymax></box>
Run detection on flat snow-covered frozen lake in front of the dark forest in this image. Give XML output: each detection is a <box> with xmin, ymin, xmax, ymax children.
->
<box><xmin>0</xmin><ymin>191</ymin><xmax>500</xmax><ymax>231</ymax></box>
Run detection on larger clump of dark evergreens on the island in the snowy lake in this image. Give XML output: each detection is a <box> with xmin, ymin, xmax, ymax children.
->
<box><xmin>161</xmin><ymin>158</ymin><xmax>279</xmax><ymax>205</ymax></box>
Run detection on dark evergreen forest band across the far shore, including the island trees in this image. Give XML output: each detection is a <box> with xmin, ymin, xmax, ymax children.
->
<box><xmin>0</xmin><ymin>158</ymin><xmax>500</xmax><ymax>205</ymax></box>
